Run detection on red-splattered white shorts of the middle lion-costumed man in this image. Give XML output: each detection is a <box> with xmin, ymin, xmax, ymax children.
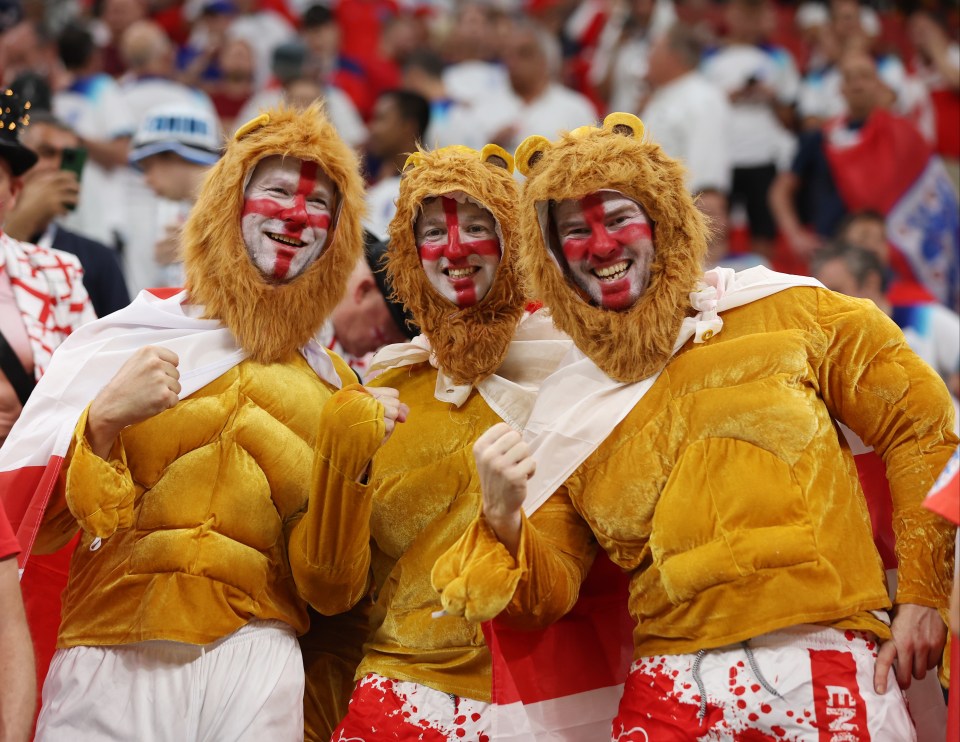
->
<box><xmin>331</xmin><ymin>673</ymin><xmax>491</xmax><ymax>742</ymax></box>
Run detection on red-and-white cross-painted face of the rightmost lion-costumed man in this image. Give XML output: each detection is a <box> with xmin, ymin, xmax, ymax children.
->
<box><xmin>551</xmin><ymin>191</ymin><xmax>654</xmax><ymax>311</ymax></box>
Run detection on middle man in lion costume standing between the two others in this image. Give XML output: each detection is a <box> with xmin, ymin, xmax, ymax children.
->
<box><xmin>288</xmin><ymin>145</ymin><xmax>576</xmax><ymax>741</ymax></box>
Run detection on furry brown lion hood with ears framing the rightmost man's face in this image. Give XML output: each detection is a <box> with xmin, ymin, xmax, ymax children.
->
<box><xmin>516</xmin><ymin>114</ymin><xmax>707</xmax><ymax>382</ymax></box>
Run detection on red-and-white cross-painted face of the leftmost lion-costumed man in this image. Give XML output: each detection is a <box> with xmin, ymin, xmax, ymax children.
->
<box><xmin>241</xmin><ymin>155</ymin><xmax>336</xmax><ymax>283</ymax></box>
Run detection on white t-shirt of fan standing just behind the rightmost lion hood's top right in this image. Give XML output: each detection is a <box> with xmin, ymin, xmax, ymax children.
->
<box><xmin>640</xmin><ymin>71</ymin><xmax>731</xmax><ymax>193</ymax></box>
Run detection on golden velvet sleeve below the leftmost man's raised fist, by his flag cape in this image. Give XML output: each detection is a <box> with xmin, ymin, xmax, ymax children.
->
<box><xmin>36</xmin><ymin>406</ymin><xmax>136</xmax><ymax>553</ymax></box>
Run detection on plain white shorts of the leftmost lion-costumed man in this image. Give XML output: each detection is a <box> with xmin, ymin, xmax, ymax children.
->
<box><xmin>36</xmin><ymin>621</ymin><xmax>304</xmax><ymax>742</ymax></box>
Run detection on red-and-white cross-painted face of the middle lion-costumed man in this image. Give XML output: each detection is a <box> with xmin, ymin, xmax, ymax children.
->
<box><xmin>413</xmin><ymin>196</ymin><xmax>500</xmax><ymax>308</ymax></box>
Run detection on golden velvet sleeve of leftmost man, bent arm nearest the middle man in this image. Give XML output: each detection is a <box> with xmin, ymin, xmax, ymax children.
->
<box><xmin>288</xmin><ymin>384</ymin><xmax>386</xmax><ymax>615</ymax></box>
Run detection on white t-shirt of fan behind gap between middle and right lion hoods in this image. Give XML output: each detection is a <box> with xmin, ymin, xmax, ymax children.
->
<box><xmin>501</xmin><ymin>82</ymin><xmax>597</xmax><ymax>152</ymax></box>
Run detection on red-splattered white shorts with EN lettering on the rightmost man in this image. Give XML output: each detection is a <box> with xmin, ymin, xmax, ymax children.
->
<box><xmin>613</xmin><ymin>626</ymin><xmax>916</xmax><ymax>742</ymax></box>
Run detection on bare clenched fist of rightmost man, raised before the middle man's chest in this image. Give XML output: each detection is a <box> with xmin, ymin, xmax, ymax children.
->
<box><xmin>473</xmin><ymin>423</ymin><xmax>536</xmax><ymax>556</ymax></box>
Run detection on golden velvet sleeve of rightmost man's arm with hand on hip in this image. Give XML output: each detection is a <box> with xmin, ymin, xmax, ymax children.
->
<box><xmin>817</xmin><ymin>290</ymin><xmax>957</xmax><ymax>610</ymax></box>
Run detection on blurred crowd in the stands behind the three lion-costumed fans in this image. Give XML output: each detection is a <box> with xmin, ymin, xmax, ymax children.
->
<box><xmin>0</xmin><ymin>0</ymin><xmax>960</xmax><ymax>402</ymax></box>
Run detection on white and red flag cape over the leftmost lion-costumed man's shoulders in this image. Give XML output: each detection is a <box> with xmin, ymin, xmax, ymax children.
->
<box><xmin>0</xmin><ymin>291</ymin><xmax>341</xmax><ymax>575</ymax></box>
